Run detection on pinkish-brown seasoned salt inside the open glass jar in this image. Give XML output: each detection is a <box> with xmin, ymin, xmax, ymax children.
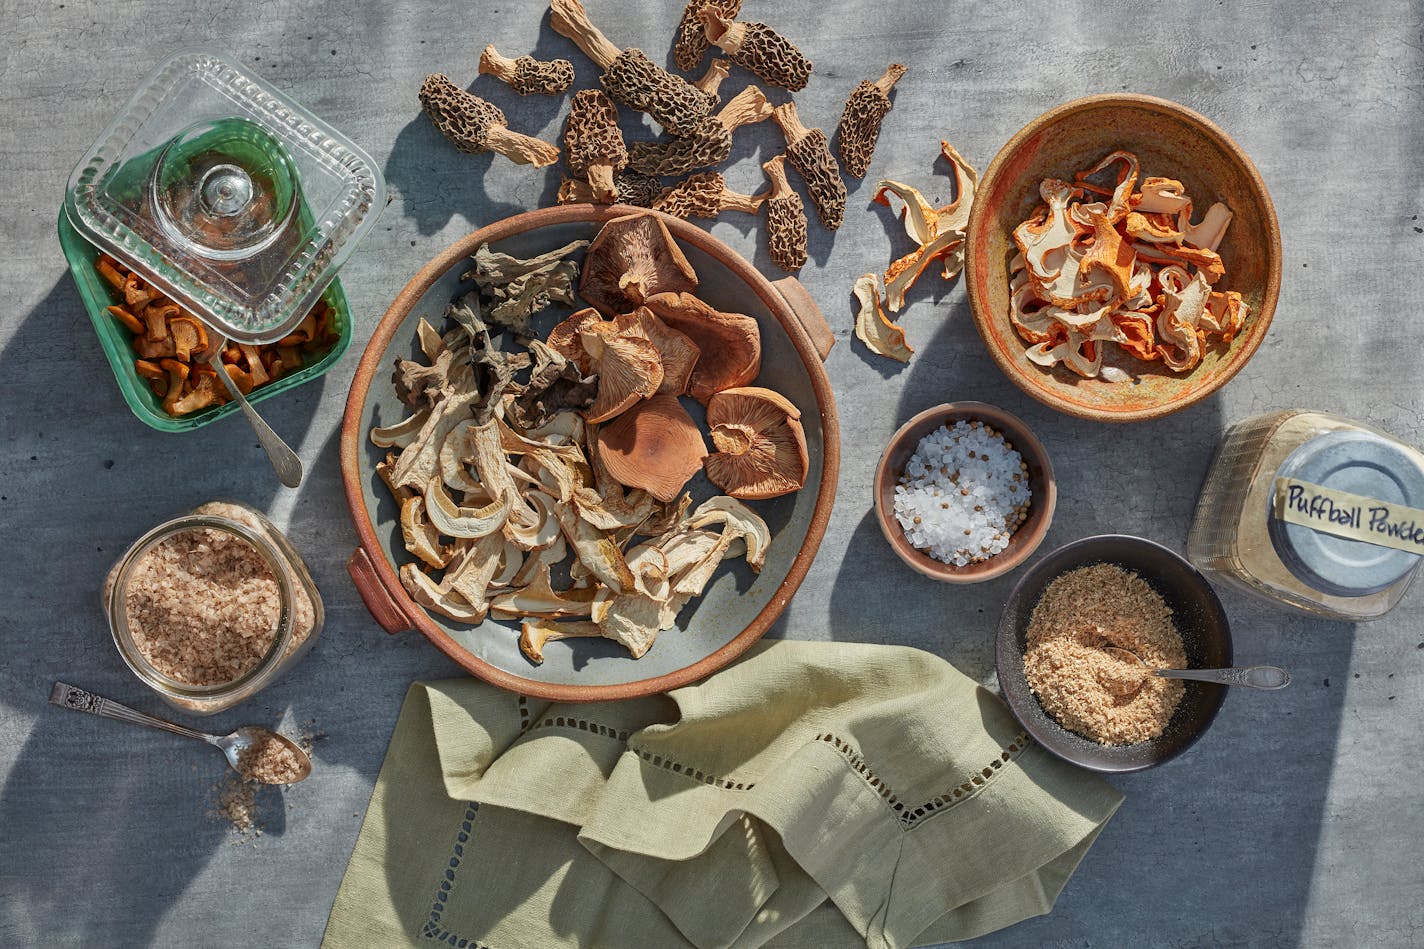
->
<box><xmin>124</xmin><ymin>529</ymin><xmax>282</xmax><ymax>685</ymax></box>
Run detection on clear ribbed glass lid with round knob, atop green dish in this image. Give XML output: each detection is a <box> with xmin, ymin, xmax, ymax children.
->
<box><xmin>64</xmin><ymin>51</ymin><xmax>386</xmax><ymax>343</ymax></box>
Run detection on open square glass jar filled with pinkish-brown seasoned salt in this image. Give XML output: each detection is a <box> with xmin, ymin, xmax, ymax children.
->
<box><xmin>103</xmin><ymin>502</ymin><xmax>323</xmax><ymax>715</ymax></box>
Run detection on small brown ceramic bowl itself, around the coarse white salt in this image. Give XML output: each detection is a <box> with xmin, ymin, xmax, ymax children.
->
<box><xmin>874</xmin><ymin>402</ymin><xmax>1058</xmax><ymax>583</ymax></box>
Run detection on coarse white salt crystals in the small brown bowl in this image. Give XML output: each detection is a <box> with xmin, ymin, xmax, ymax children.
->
<box><xmin>894</xmin><ymin>422</ymin><xmax>1032</xmax><ymax>567</ymax></box>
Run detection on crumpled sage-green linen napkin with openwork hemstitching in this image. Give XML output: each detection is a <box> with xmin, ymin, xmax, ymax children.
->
<box><xmin>322</xmin><ymin>641</ymin><xmax>1122</xmax><ymax>949</ymax></box>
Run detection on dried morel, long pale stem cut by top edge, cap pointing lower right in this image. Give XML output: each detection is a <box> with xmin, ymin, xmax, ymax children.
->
<box><xmin>548</xmin><ymin>0</ymin><xmax>716</xmax><ymax>135</ymax></box>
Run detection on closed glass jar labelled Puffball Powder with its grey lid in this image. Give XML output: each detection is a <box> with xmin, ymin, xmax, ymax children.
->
<box><xmin>1186</xmin><ymin>410</ymin><xmax>1424</xmax><ymax>621</ymax></box>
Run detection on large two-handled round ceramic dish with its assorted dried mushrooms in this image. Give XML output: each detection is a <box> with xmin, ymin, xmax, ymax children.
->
<box><xmin>342</xmin><ymin>205</ymin><xmax>839</xmax><ymax>701</ymax></box>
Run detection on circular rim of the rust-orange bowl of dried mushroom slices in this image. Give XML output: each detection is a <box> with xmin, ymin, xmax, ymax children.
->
<box><xmin>964</xmin><ymin>93</ymin><xmax>1282</xmax><ymax>422</ymax></box>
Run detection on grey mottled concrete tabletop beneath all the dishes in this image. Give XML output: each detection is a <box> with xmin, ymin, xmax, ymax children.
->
<box><xmin>0</xmin><ymin>0</ymin><xmax>1424</xmax><ymax>948</ymax></box>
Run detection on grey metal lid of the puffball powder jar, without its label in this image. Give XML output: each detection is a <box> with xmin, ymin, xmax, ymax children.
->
<box><xmin>1267</xmin><ymin>429</ymin><xmax>1424</xmax><ymax>597</ymax></box>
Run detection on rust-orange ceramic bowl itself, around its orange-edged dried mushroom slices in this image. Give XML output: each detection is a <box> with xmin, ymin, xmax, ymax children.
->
<box><xmin>964</xmin><ymin>94</ymin><xmax>1280</xmax><ymax>422</ymax></box>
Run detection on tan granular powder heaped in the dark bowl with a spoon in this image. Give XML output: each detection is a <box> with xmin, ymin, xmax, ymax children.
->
<box><xmin>1024</xmin><ymin>564</ymin><xmax>1186</xmax><ymax>745</ymax></box>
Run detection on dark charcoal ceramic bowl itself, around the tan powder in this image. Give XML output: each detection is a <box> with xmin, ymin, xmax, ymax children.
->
<box><xmin>995</xmin><ymin>534</ymin><xmax>1232</xmax><ymax>772</ymax></box>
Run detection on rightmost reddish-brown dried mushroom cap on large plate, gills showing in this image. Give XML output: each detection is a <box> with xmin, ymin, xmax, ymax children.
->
<box><xmin>703</xmin><ymin>386</ymin><xmax>810</xmax><ymax>499</ymax></box>
